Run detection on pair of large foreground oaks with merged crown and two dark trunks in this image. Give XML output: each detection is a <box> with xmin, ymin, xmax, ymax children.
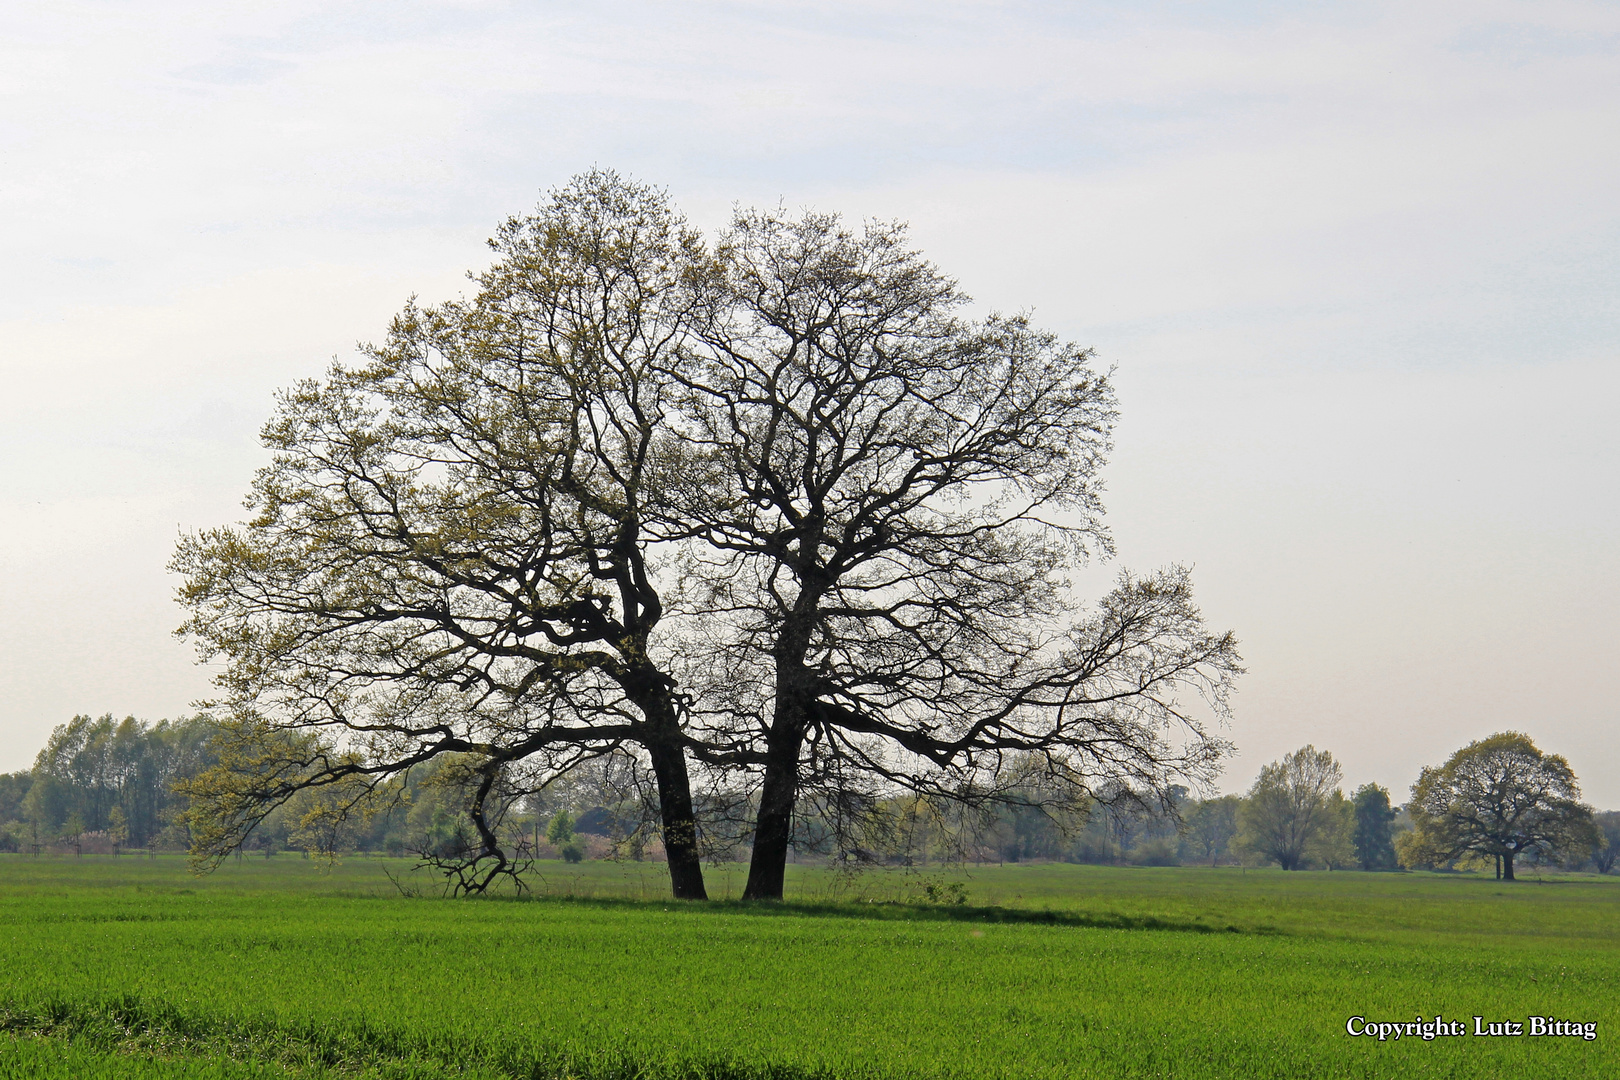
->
<box><xmin>175</xmin><ymin>172</ymin><xmax>1239</xmax><ymax>897</ymax></box>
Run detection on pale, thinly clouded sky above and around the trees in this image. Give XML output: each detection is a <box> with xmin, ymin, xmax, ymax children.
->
<box><xmin>0</xmin><ymin>0</ymin><xmax>1620</xmax><ymax>808</ymax></box>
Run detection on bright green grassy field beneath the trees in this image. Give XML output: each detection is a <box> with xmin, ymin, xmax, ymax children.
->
<box><xmin>0</xmin><ymin>855</ymin><xmax>1620</xmax><ymax>1080</ymax></box>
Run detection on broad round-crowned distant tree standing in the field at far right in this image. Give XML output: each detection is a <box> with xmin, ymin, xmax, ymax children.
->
<box><xmin>1408</xmin><ymin>732</ymin><xmax>1602</xmax><ymax>881</ymax></box>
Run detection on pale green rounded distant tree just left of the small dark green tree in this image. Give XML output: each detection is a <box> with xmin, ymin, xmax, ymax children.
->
<box><xmin>1239</xmin><ymin>746</ymin><xmax>1348</xmax><ymax>870</ymax></box>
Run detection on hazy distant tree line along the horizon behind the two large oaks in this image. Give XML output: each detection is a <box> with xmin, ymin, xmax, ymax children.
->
<box><xmin>0</xmin><ymin>716</ymin><xmax>1620</xmax><ymax>878</ymax></box>
